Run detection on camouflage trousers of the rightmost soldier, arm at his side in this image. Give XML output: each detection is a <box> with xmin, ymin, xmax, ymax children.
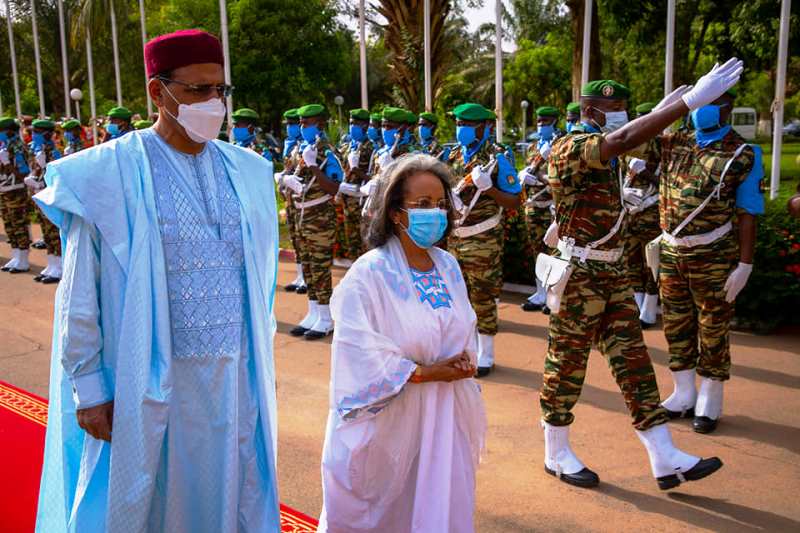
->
<box><xmin>659</xmin><ymin>234</ymin><xmax>739</xmax><ymax>380</ymax></box>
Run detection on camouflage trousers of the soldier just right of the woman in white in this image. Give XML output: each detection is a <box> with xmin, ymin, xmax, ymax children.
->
<box><xmin>448</xmin><ymin>223</ymin><xmax>503</xmax><ymax>335</ymax></box>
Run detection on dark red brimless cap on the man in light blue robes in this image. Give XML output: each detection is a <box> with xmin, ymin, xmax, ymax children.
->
<box><xmin>144</xmin><ymin>30</ymin><xmax>225</xmax><ymax>78</ymax></box>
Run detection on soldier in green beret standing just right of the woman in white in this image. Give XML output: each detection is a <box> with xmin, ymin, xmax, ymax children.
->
<box><xmin>448</xmin><ymin>104</ymin><xmax>522</xmax><ymax>377</ymax></box>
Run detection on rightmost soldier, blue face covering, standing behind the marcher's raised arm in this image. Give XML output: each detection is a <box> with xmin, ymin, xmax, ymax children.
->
<box><xmin>652</xmin><ymin>90</ymin><xmax>764</xmax><ymax>433</ymax></box>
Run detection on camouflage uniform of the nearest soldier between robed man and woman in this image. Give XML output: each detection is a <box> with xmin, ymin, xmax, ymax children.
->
<box><xmin>292</xmin><ymin>140</ymin><xmax>338</xmax><ymax>305</ymax></box>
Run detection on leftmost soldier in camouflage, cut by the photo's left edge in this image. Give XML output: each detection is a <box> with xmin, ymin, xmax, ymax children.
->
<box><xmin>0</xmin><ymin>117</ymin><xmax>31</xmax><ymax>274</ymax></box>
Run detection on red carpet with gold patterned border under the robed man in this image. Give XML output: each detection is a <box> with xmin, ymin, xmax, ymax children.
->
<box><xmin>0</xmin><ymin>381</ymin><xmax>317</xmax><ymax>533</ymax></box>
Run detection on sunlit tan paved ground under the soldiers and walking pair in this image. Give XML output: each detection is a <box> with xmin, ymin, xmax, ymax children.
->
<box><xmin>0</xmin><ymin>230</ymin><xmax>800</xmax><ymax>532</ymax></box>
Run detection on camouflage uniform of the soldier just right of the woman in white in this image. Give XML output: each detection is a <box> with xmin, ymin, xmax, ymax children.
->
<box><xmin>448</xmin><ymin>142</ymin><xmax>504</xmax><ymax>335</ymax></box>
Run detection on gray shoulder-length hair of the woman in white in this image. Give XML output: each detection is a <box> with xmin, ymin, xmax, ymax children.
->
<box><xmin>364</xmin><ymin>154</ymin><xmax>455</xmax><ymax>248</ymax></box>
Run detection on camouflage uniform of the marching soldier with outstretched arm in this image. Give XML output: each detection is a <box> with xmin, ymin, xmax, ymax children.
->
<box><xmin>540</xmin><ymin>127</ymin><xmax>668</xmax><ymax>431</ymax></box>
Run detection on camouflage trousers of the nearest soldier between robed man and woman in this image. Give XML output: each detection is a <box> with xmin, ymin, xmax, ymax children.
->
<box><xmin>295</xmin><ymin>202</ymin><xmax>336</xmax><ymax>305</ymax></box>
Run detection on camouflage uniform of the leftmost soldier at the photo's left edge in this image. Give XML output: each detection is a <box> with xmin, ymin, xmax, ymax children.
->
<box><xmin>0</xmin><ymin>136</ymin><xmax>32</xmax><ymax>250</ymax></box>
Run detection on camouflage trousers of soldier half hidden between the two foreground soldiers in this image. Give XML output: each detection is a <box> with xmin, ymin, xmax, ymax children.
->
<box><xmin>623</xmin><ymin>204</ymin><xmax>661</xmax><ymax>294</ymax></box>
